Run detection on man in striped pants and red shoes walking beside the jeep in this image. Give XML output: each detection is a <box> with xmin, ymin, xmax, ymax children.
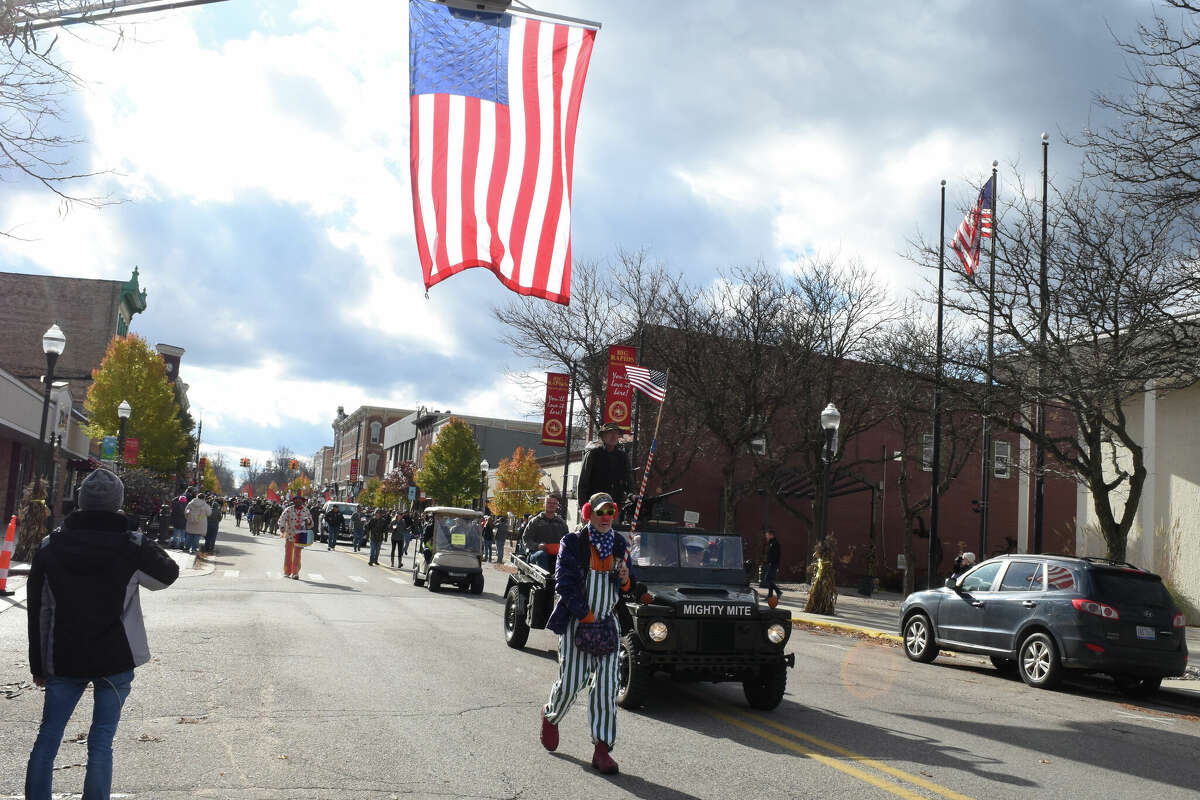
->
<box><xmin>539</xmin><ymin>493</ymin><xmax>632</xmax><ymax>775</ymax></box>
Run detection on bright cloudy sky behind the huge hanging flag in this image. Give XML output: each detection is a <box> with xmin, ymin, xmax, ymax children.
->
<box><xmin>0</xmin><ymin>0</ymin><xmax>1156</xmax><ymax>472</ymax></box>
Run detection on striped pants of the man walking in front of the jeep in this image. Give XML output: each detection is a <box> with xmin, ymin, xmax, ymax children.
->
<box><xmin>544</xmin><ymin>620</ymin><xmax>617</xmax><ymax>750</ymax></box>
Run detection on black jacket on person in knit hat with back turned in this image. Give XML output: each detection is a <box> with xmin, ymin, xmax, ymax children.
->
<box><xmin>28</xmin><ymin>511</ymin><xmax>179</xmax><ymax>678</ymax></box>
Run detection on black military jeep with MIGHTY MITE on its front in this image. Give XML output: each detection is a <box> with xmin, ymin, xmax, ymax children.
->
<box><xmin>504</xmin><ymin>522</ymin><xmax>796</xmax><ymax>710</ymax></box>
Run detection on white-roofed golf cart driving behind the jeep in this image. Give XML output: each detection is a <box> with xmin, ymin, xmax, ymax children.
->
<box><xmin>413</xmin><ymin>506</ymin><xmax>484</xmax><ymax>595</ymax></box>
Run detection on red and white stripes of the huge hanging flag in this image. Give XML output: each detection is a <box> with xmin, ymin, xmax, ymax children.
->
<box><xmin>410</xmin><ymin>16</ymin><xmax>595</xmax><ymax>305</ymax></box>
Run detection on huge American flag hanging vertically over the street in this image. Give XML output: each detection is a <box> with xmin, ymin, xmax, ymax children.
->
<box><xmin>408</xmin><ymin>0</ymin><xmax>595</xmax><ymax>305</ymax></box>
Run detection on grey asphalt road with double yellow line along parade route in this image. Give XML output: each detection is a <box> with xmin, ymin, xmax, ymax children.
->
<box><xmin>0</xmin><ymin>527</ymin><xmax>1200</xmax><ymax>800</ymax></box>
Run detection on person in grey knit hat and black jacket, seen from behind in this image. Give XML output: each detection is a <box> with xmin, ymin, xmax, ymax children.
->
<box><xmin>24</xmin><ymin>469</ymin><xmax>179</xmax><ymax>800</ymax></box>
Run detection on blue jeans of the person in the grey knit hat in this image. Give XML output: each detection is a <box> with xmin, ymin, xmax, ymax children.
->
<box><xmin>25</xmin><ymin>669</ymin><xmax>133</xmax><ymax>800</ymax></box>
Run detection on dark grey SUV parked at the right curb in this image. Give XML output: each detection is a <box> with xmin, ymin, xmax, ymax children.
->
<box><xmin>900</xmin><ymin>554</ymin><xmax>1188</xmax><ymax>697</ymax></box>
